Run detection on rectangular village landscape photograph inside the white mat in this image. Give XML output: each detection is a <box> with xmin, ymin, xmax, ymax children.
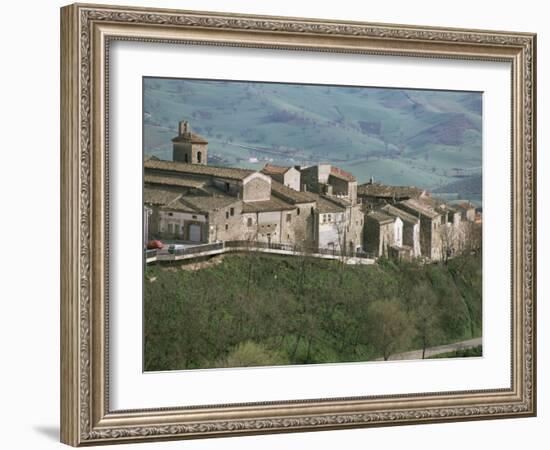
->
<box><xmin>144</xmin><ymin>76</ymin><xmax>483</xmax><ymax>372</ymax></box>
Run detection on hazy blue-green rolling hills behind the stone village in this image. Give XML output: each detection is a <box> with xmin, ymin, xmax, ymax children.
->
<box><xmin>143</xmin><ymin>78</ymin><xmax>482</xmax><ymax>202</ymax></box>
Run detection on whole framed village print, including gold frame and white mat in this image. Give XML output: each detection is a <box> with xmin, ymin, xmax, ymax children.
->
<box><xmin>61</xmin><ymin>4</ymin><xmax>536</xmax><ymax>446</ymax></box>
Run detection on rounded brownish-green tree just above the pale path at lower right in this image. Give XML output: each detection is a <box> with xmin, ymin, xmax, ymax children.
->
<box><xmin>367</xmin><ymin>300</ymin><xmax>411</xmax><ymax>361</ymax></box>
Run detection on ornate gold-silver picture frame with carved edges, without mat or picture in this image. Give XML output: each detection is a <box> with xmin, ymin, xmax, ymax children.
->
<box><xmin>61</xmin><ymin>4</ymin><xmax>536</xmax><ymax>446</ymax></box>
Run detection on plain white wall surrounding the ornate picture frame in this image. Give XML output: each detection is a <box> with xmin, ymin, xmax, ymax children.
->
<box><xmin>0</xmin><ymin>0</ymin><xmax>550</xmax><ymax>450</ymax></box>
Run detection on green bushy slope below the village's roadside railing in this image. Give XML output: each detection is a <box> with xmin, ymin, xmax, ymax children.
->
<box><xmin>144</xmin><ymin>253</ymin><xmax>481</xmax><ymax>371</ymax></box>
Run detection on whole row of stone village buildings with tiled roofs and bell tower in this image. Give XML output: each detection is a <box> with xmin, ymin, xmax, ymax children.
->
<box><xmin>144</xmin><ymin>121</ymin><xmax>481</xmax><ymax>261</ymax></box>
